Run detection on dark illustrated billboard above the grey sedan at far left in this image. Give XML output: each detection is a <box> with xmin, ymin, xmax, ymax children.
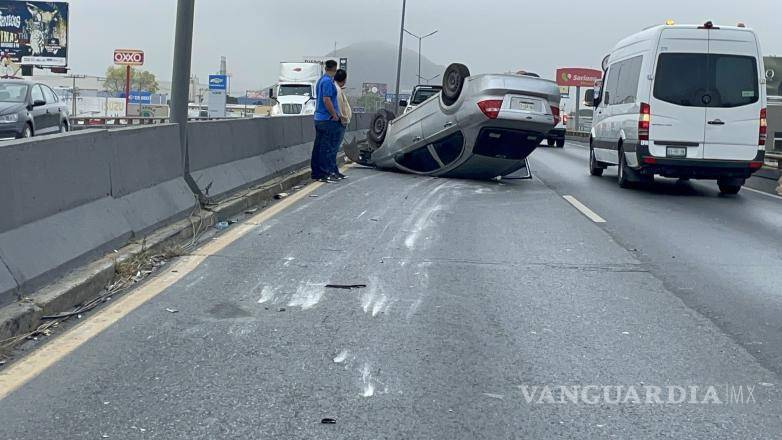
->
<box><xmin>0</xmin><ymin>0</ymin><xmax>68</xmax><ymax>67</ymax></box>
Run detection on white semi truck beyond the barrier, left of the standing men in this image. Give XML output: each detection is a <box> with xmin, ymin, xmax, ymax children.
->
<box><xmin>269</xmin><ymin>62</ymin><xmax>323</xmax><ymax>116</ymax></box>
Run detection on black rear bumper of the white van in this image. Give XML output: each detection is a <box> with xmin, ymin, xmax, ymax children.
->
<box><xmin>636</xmin><ymin>145</ymin><xmax>765</xmax><ymax>179</ymax></box>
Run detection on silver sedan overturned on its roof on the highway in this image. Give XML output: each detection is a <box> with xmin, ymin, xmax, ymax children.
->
<box><xmin>345</xmin><ymin>64</ymin><xmax>560</xmax><ymax>179</ymax></box>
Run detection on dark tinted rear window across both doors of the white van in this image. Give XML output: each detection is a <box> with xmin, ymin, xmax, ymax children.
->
<box><xmin>654</xmin><ymin>53</ymin><xmax>760</xmax><ymax>107</ymax></box>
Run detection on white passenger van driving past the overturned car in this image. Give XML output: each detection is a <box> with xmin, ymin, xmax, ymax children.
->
<box><xmin>587</xmin><ymin>22</ymin><xmax>766</xmax><ymax>194</ymax></box>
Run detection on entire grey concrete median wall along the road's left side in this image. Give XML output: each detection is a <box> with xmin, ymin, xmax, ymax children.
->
<box><xmin>0</xmin><ymin>115</ymin><xmax>371</xmax><ymax>306</ymax></box>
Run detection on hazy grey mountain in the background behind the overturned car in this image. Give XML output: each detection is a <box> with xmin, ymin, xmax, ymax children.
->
<box><xmin>326</xmin><ymin>41</ymin><xmax>445</xmax><ymax>95</ymax></box>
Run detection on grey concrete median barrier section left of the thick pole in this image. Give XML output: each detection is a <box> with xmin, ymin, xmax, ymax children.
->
<box><xmin>0</xmin><ymin>125</ymin><xmax>195</xmax><ymax>305</ymax></box>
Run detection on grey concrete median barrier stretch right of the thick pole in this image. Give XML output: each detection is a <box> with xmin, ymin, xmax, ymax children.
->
<box><xmin>187</xmin><ymin>114</ymin><xmax>370</xmax><ymax>200</ymax></box>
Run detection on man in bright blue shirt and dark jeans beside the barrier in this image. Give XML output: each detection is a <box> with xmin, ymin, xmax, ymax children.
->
<box><xmin>310</xmin><ymin>60</ymin><xmax>342</xmax><ymax>183</ymax></box>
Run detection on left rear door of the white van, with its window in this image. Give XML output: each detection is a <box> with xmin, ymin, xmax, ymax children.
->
<box><xmin>649</xmin><ymin>28</ymin><xmax>709</xmax><ymax>159</ymax></box>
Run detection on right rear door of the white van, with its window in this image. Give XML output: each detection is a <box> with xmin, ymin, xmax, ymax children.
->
<box><xmin>704</xmin><ymin>29</ymin><xmax>763</xmax><ymax>160</ymax></box>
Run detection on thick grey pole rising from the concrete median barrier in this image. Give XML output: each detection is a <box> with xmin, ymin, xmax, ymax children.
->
<box><xmin>171</xmin><ymin>0</ymin><xmax>204</xmax><ymax>201</ymax></box>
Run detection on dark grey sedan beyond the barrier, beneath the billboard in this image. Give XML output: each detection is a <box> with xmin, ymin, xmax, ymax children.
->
<box><xmin>0</xmin><ymin>80</ymin><xmax>69</xmax><ymax>138</ymax></box>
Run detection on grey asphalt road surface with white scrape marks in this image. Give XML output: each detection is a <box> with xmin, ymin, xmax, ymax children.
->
<box><xmin>0</xmin><ymin>154</ymin><xmax>782</xmax><ymax>439</ymax></box>
